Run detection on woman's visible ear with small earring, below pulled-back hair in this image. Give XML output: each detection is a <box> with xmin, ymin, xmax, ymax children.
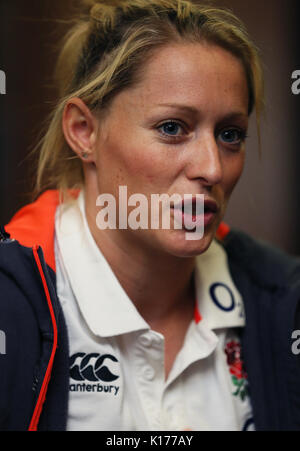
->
<box><xmin>62</xmin><ymin>97</ymin><xmax>98</xmax><ymax>163</ymax></box>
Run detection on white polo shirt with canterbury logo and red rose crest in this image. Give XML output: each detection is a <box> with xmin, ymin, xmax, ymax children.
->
<box><xmin>55</xmin><ymin>192</ymin><xmax>254</xmax><ymax>431</ymax></box>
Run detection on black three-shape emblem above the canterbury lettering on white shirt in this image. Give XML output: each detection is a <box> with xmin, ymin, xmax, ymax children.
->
<box><xmin>70</xmin><ymin>352</ymin><xmax>119</xmax><ymax>382</ymax></box>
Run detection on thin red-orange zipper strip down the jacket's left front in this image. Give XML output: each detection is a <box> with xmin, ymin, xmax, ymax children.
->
<box><xmin>28</xmin><ymin>246</ymin><xmax>57</xmax><ymax>431</ymax></box>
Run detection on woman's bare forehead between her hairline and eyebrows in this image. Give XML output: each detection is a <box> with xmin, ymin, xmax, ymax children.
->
<box><xmin>124</xmin><ymin>43</ymin><xmax>249</xmax><ymax>114</ymax></box>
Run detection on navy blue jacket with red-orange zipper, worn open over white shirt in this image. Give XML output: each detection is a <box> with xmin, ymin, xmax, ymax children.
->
<box><xmin>0</xmin><ymin>224</ymin><xmax>300</xmax><ymax>431</ymax></box>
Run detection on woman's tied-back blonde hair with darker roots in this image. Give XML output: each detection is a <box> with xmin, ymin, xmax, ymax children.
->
<box><xmin>35</xmin><ymin>0</ymin><xmax>263</xmax><ymax>200</ymax></box>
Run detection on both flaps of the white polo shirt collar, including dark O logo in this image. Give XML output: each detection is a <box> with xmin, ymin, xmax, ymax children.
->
<box><xmin>55</xmin><ymin>191</ymin><xmax>245</xmax><ymax>337</ymax></box>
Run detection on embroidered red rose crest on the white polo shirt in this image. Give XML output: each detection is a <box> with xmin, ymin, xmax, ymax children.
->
<box><xmin>224</xmin><ymin>340</ymin><xmax>248</xmax><ymax>401</ymax></box>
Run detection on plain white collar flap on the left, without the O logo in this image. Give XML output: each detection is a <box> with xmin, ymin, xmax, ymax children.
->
<box><xmin>55</xmin><ymin>191</ymin><xmax>149</xmax><ymax>337</ymax></box>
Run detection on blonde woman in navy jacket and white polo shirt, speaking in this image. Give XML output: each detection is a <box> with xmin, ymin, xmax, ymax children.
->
<box><xmin>0</xmin><ymin>0</ymin><xmax>300</xmax><ymax>431</ymax></box>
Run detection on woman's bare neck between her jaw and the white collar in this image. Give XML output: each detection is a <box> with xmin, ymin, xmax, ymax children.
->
<box><xmin>86</xmin><ymin>191</ymin><xmax>195</xmax><ymax>324</ymax></box>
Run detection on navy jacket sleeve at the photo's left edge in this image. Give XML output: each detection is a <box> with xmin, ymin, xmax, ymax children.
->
<box><xmin>0</xmin><ymin>269</ymin><xmax>40</xmax><ymax>430</ymax></box>
